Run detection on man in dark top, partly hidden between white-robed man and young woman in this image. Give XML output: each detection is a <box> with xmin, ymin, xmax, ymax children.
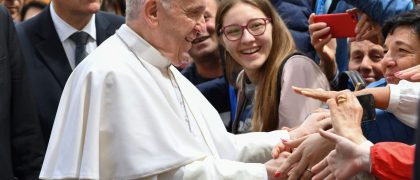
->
<box><xmin>181</xmin><ymin>0</ymin><xmax>231</xmax><ymax>127</ymax></box>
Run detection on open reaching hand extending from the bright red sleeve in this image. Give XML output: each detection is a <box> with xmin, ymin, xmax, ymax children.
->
<box><xmin>311</xmin><ymin>130</ymin><xmax>370</xmax><ymax>180</ymax></box>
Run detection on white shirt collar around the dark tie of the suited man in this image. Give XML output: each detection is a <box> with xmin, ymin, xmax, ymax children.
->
<box><xmin>50</xmin><ymin>2</ymin><xmax>96</xmax><ymax>42</ymax></box>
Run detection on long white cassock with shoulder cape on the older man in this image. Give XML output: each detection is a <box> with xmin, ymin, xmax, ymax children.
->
<box><xmin>40</xmin><ymin>25</ymin><xmax>289</xmax><ymax>180</ymax></box>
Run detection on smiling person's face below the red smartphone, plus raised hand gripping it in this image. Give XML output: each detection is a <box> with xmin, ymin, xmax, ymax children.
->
<box><xmin>308</xmin><ymin>14</ymin><xmax>384</xmax><ymax>87</ymax></box>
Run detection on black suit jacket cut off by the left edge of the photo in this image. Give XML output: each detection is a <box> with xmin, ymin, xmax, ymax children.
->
<box><xmin>0</xmin><ymin>6</ymin><xmax>45</xmax><ymax>180</ymax></box>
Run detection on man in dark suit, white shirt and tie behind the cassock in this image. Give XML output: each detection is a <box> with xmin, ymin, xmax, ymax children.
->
<box><xmin>16</xmin><ymin>0</ymin><xmax>124</xmax><ymax>143</ymax></box>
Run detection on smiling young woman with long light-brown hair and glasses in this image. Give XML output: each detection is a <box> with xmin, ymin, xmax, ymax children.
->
<box><xmin>216</xmin><ymin>0</ymin><xmax>329</xmax><ymax>133</ymax></box>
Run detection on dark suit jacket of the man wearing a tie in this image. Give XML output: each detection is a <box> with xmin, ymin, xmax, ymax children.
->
<box><xmin>17</xmin><ymin>7</ymin><xmax>124</xmax><ymax>145</ymax></box>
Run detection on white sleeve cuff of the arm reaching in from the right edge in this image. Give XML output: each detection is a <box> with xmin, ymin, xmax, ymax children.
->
<box><xmin>387</xmin><ymin>80</ymin><xmax>420</xmax><ymax>128</ymax></box>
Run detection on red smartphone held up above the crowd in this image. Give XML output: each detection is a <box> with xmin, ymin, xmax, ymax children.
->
<box><xmin>314</xmin><ymin>13</ymin><xmax>358</xmax><ymax>38</ymax></box>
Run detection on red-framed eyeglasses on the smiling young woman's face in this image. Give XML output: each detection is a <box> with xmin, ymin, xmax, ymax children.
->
<box><xmin>220</xmin><ymin>18</ymin><xmax>271</xmax><ymax>41</ymax></box>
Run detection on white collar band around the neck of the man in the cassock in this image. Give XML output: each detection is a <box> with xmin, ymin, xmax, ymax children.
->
<box><xmin>116</xmin><ymin>24</ymin><xmax>171</xmax><ymax>70</ymax></box>
